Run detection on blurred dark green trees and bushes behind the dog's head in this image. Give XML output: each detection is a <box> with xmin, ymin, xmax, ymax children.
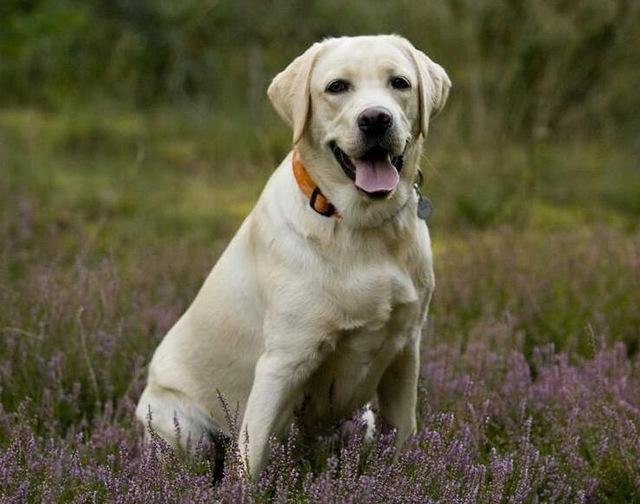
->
<box><xmin>0</xmin><ymin>0</ymin><xmax>640</xmax><ymax>141</ymax></box>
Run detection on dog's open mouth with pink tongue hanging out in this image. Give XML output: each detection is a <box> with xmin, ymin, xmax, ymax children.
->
<box><xmin>330</xmin><ymin>142</ymin><xmax>403</xmax><ymax>198</ymax></box>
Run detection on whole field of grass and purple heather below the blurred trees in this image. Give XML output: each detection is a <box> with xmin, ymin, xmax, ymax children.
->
<box><xmin>0</xmin><ymin>104</ymin><xmax>640</xmax><ymax>503</ymax></box>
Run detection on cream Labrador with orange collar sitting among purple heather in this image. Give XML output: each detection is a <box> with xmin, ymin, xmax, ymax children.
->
<box><xmin>136</xmin><ymin>35</ymin><xmax>451</xmax><ymax>477</ymax></box>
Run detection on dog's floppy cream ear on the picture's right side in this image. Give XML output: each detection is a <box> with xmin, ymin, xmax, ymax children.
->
<box><xmin>407</xmin><ymin>42</ymin><xmax>451</xmax><ymax>138</ymax></box>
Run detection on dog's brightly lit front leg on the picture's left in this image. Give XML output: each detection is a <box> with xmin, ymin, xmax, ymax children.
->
<box><xmin>239</xmin><ymin>322</ymin><xmax>330</xmax><ymax>477</ymax></box>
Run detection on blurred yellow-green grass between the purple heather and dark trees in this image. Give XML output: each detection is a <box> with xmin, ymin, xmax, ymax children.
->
<box><xmin>0</xmin><ymin>106</ymin><xmax>640</xmax><ymax>353</ymax></box>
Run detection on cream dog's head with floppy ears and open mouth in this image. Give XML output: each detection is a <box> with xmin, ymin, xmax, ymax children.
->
<box><xmin>268</xmin><ymin>35</ymin><xmax>451</xmax><ymax>224</ymax></box>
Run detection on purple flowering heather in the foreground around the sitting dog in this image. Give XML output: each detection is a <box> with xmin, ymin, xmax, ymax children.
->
<box><xmin>0</xmin><ymin>235</ymin><xmax>640</xmax><ymax>504</ymax></box>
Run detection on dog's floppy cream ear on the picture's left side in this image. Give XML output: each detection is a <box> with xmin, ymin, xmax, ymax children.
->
<box><xmin>267</xmin><ymin>43</ymin><xmax>321</xmax><ymax>145</ymax></box>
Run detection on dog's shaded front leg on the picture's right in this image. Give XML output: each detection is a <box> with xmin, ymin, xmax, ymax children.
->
<box><xmin>378</xmin><ymin>336</ymin><xmax>420</xmax><ymax>447</ymax></box>
